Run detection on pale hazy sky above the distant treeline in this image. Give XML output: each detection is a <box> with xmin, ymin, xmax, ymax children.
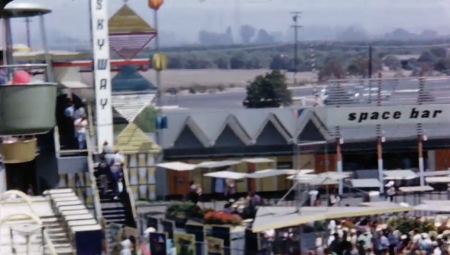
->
<box><xmin>7</xmin><ymin>0</ymin><xmax>450</xmax><ymax>41</ymax></box>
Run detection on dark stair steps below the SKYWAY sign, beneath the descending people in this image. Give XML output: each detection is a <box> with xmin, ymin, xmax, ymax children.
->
<box><xmin>95</xmin><ymin>173</ymin><xmax>132</xmax><ymax>226</ymax></box>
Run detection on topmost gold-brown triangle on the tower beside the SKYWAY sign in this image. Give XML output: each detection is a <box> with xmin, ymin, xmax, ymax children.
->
<box><xmin>108</xmin><ymin>4</ymin><xmax>156</xmax><ymax>34</ymax></box>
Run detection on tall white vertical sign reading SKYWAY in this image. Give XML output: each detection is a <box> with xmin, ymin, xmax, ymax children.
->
<box><xmin>90</xmin><ymin>0</ymin><xmax>114</xmax><ymax>151</ymax></box>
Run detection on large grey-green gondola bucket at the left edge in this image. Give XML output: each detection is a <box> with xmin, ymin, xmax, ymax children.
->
<box><xmin>0</xmin><ymin>83</ymin><xmax>57</xmax><ymax>135</ymax></box>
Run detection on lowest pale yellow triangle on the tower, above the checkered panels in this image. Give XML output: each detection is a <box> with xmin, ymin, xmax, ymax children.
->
<box><xmin>114</xmin><ymin>123</ymin><xmax>161</xmax><ymax>153</ymax></box>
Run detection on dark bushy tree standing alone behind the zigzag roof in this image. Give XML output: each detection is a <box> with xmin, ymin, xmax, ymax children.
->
<box><xmin>243</xmin><ymin>70</ymin><xmax>292</xmax><ymax>108</ymax></box>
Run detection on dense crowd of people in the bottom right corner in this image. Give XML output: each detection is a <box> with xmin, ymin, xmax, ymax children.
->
<box><xmin>309</xmin><ymin>217</ymin><xmax>450</xmax><ymax>255</ymax></box>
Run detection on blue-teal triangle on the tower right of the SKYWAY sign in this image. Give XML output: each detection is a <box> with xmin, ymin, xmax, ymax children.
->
<box><xmin>111</xmin><ymin>66</ymin><xmax>156</xmax><ymax>93</ymax></box>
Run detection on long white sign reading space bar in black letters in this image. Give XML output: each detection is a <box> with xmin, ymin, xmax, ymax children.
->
<box><xmin>326</xmin><ymin>105</ymin><xmax>450</xmax><ymax>127</ymax></box>
